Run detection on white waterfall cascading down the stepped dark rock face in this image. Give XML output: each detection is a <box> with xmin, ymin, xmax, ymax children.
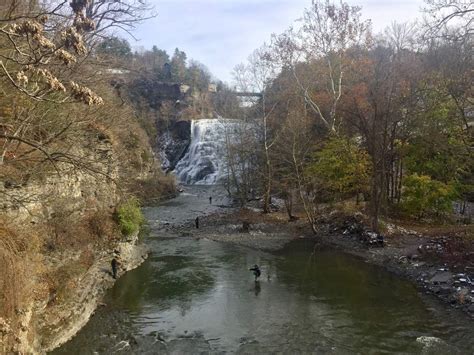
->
<box><xmin>174</xmin><ymin>118</ymin><xmax>241</xmax><ymax>185</ymax></box>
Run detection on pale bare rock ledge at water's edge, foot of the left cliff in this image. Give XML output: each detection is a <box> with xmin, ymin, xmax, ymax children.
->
<box><xmin>2</xmin><ymin>233</ymin><xmax>148</xmax><ymax>354</ymax></box>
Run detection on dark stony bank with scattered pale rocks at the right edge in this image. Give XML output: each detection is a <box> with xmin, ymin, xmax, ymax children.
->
<box><xmin>321</xmin><ymin>218</ymin><xmax>474</xmax><ymax>319</ymax></box>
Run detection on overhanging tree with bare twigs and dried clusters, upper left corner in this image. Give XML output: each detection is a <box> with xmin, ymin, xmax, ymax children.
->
<box><xmin>0</xmin><ymin>0</ymin><xmax>152</xmax><ymax>206</ymax></box>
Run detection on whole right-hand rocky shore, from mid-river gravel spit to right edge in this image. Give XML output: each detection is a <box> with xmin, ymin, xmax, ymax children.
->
<box><xmin>193</xmin><ymin>209</ymin><xmax>474</xmax><ymax>319</ymax></box>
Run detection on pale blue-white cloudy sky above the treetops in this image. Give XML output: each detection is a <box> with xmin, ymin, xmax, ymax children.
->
<box><xmin>130</xmin><ymin>0</ymin><xmax>423</xmax><ymax>82</ymax></box>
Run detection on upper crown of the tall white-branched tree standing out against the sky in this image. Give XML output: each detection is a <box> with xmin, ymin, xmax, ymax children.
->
<box><xmin>273</xmin><ymin>0</ymin><xmax>370</xmax><ymax>132</ymax></box>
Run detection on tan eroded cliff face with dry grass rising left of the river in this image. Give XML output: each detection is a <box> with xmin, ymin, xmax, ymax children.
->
<box><xmin>0</xmin><ymin>136</ymin><xmax>157</xmax><ymax>353</ymax></box>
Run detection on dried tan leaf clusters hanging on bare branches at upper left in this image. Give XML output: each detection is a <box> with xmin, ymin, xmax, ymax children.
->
<box><xmin>0</xmin><ymin>0</ymin><xmax>97</xmax><ymax>105</ymax></box>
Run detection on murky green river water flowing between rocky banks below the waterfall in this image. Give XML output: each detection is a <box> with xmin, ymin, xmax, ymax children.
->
<box><xmin>54</xmin><ymin>187</ymin><xmax>474</xmax><ymax>354</ymax></box>
